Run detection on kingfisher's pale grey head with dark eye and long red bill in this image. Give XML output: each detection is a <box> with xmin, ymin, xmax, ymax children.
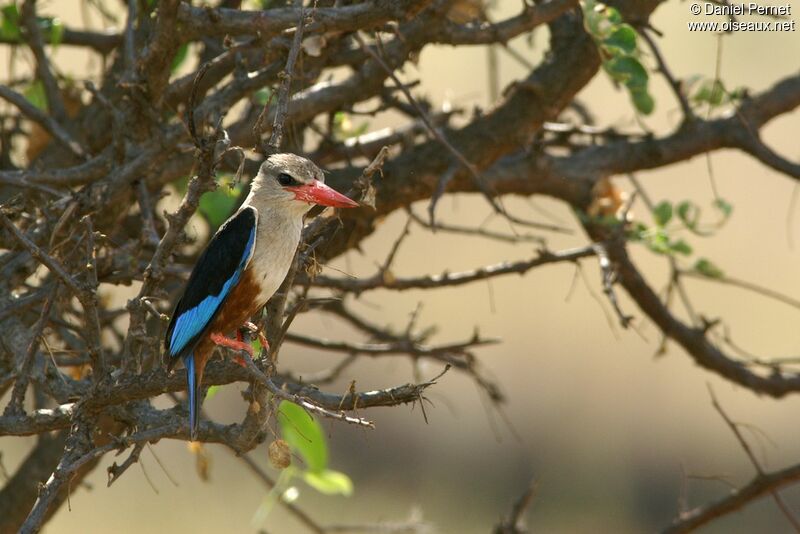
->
<box><xmin>251</xmin><ymin>154</ymin><xmax>358</xmax><ymax>213</ymax></box>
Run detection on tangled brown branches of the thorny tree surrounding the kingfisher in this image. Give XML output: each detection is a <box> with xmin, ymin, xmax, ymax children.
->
<box><xmin>0</xmin><ymin>0</ymin><xmax>800</xmax><ymax>532</ymax></box>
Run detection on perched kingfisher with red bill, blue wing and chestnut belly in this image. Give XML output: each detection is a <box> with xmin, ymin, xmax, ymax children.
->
<box><xmin>164</xmin><ymin>154</ymin><xmax>358</xmax><ymax>441</ymax></box>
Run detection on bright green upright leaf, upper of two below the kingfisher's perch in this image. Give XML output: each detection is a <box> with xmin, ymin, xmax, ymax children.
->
<box><xmin>278</xmin><ymin>400</ymin><xmax>328</xmax><ymax>473</ymax></box>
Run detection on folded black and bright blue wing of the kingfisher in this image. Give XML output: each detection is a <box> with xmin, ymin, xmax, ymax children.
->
<box><xmin>164</xmin><ymin>207</ymin><xmax>257</xmax><ymax>362</ymax></box>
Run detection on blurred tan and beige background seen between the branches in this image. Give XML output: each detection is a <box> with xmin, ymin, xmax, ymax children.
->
<box><xmin>0</xmin><ymin>0</ymin><xmax>800</xmax><ymax>533</ymax></box>
